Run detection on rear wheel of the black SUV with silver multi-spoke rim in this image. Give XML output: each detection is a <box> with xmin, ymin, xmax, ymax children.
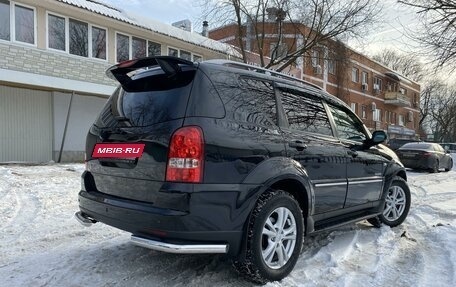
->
<box><xmin>233</xmin><ymin>190</ymin><xmax>304</xmax><ymax>284</ymax></box>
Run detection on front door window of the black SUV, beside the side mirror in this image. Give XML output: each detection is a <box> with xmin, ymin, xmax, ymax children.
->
<box><xmin>330</xmin><ymin>106</ymin><xmax>366</xmax><ymax>142</ymax></box>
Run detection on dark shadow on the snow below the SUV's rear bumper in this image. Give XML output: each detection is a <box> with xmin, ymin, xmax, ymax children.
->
<box><xmin>75</xmin><ymin>242</ymin><xmax>252</xmax><ymax>286</ymax></box>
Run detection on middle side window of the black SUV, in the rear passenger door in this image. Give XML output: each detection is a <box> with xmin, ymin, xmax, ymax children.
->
<box><xmin>282</xmin><ymin>90</ymin><xmax>332</xmax><ymax>136</ymax></box>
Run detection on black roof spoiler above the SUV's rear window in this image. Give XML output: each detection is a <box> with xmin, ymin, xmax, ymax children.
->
<box><xmin>106</xmin><ymin>56</ymin><xmax>194</xmax><ymax>86</ymax></box>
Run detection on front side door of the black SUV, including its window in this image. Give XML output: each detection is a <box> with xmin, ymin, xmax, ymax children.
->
<box><xmin>329</xmin><ymin>104</ymin><xmax>388</xmax><ymax>207</ymax></box>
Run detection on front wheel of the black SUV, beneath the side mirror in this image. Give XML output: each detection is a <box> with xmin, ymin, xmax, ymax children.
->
<box><xmin>378</xmin><ymin>176</ymin><xmax>411</xmax><ymax>227</ymax></box>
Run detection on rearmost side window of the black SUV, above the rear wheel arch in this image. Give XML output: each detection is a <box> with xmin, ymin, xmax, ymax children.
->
<box><xmin>211</xmin><ymin>71</ymin><xmax>277</xmax><ymax>126</ymax></box>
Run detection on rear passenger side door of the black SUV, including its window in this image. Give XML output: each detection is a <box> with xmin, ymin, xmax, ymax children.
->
<box><xmin>280</xmin><ymin>87</ymin><xmax>347</xmax><ymax>214</ymax></box>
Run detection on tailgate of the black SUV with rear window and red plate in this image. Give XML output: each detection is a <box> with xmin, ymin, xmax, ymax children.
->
<box><xmin>86</xmin><ymin>58</ymin><xmax>197</xmax><ymax>202</ymax></box>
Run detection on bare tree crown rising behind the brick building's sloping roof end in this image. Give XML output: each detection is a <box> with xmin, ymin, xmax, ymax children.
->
<box><xmin>372</xmin><ymin>49</ymin><xmax>425</xmax><ymax>82</ymax></box>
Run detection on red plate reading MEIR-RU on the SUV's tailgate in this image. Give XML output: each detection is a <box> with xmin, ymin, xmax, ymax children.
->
<box><xmin>92</xmin><ymin>143</ymin><xmax>145</xmax><ymax>158</ymax></box>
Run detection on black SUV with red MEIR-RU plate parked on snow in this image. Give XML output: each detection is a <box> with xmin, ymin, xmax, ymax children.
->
<box><xmin>76</xmin><ymin>57</ymin><xmax>410</xmax><ymax>283</ymax></box>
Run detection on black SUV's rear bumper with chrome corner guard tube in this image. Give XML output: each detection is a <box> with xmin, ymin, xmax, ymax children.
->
<box><xmin>77</xmin><ymin>185</ymin><xmax>254</xmax><ymax>256</ymax></box>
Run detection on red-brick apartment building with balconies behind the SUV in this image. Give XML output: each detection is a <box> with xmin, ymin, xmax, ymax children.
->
<box><xmin>209</xmin><ymin>22</ymin><xmax>420</xmax><ymax>141</ymax></box>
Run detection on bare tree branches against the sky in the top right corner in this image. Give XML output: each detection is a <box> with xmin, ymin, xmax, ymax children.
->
<box><xmin>398</xmin><ymin>0</ymin><xmax>456</xmax><ymax>70</ymax></box>
